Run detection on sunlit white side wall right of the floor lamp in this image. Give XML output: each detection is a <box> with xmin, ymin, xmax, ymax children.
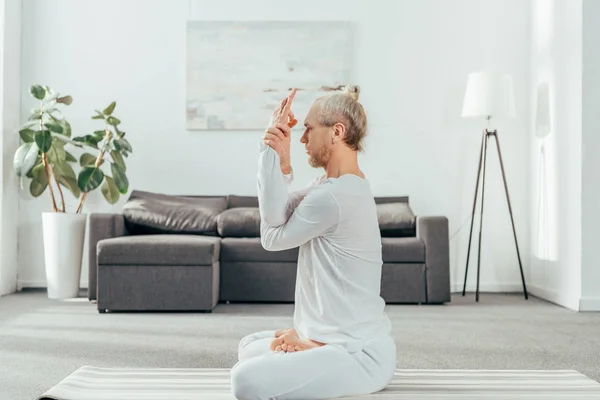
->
<box><xmin>529</xmin><ymin>0</ymin><xmax>582</xmax><ymax>310</ymax></box>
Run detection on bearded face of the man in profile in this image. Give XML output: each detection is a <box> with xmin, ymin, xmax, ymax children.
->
<box><xmin>300</xmin><ymin>104</ymin><xmax>332</xmax><ymax>168</ymax></box>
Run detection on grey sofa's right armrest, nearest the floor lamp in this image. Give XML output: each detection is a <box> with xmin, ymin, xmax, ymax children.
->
<box><xmin>417</xmin><ymin>216</ymin><xmax>450</xmax><ymax>303</ymax></box>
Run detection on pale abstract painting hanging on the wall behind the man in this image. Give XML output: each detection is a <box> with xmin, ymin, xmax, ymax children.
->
<box><xmin>186</xmin><ymin>21</ymin><xmax>356</xmax><ymax>130</ymax></box>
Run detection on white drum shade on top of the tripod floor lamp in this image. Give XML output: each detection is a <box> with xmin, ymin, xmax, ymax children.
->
<box><xmin>462</xmin><ymin>71</ymin><xmax>515</xmax><ymax>118</ymax></box>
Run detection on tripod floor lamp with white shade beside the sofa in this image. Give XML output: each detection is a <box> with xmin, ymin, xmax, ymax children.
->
<box><xmin>462</xmin><ymin>72</ymin><xmax>528</xmax><ymax>301</ymax></box>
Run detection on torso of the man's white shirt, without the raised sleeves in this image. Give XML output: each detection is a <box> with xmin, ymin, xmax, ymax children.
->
<box><xmin>294</xmin><ymin>174</ymin><xmax>391</xmax><ymax>350</ymax></box>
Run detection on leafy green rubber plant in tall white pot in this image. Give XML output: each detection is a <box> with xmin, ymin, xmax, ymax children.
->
<box><xmin>13</xmin><ymin>84</ymin><xmax>132</xmax><ymax>299</ymax></box>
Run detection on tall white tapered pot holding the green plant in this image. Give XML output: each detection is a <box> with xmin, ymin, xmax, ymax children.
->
<box><xmin>42</xmin><ymin>212</ymin><xmax>87</xmax><ymax>299</ymax></box>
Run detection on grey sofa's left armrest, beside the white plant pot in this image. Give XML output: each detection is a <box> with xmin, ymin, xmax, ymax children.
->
<box><xmin>88</xmin><ymin>213</ymin><xmax>127</xmax><ymax>300</ymax></box>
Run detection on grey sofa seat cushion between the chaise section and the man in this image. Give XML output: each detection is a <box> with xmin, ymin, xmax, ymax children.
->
<box><xmin>220</xmin><ymin>238</ymin><xmax>298</xmax><ymax>262</ymax></box>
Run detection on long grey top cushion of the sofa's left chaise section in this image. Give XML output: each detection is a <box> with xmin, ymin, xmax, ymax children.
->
<box><xmin>97</xmin><ymin>234</ymin><xmax>221</xmax><ymax>265</ymax></box>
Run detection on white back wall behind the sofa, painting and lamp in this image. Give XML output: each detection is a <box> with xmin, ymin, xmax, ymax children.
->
<box><xmin>19</xmin><ymin>0</ymin><xmax>531</xmax><ymax>290</ymax></box>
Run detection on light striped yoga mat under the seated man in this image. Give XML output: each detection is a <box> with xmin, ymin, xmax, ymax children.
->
<box><xmin>38</xmin><ymin>366</ymin><xmax>600</xmax><ymax>400</ymax></box>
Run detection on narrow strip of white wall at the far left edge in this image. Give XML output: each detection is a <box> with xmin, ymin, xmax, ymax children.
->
<box><xmin>0</xmin><ymin>0</ymin><xmax>21</xmax><ymax>296</ymax></box>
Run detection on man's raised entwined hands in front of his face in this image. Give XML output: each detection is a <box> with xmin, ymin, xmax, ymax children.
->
<box><xmin>263</xmin><ymin>89</ymin><xmax>298</xmax><ymax>175</ymax></box>
